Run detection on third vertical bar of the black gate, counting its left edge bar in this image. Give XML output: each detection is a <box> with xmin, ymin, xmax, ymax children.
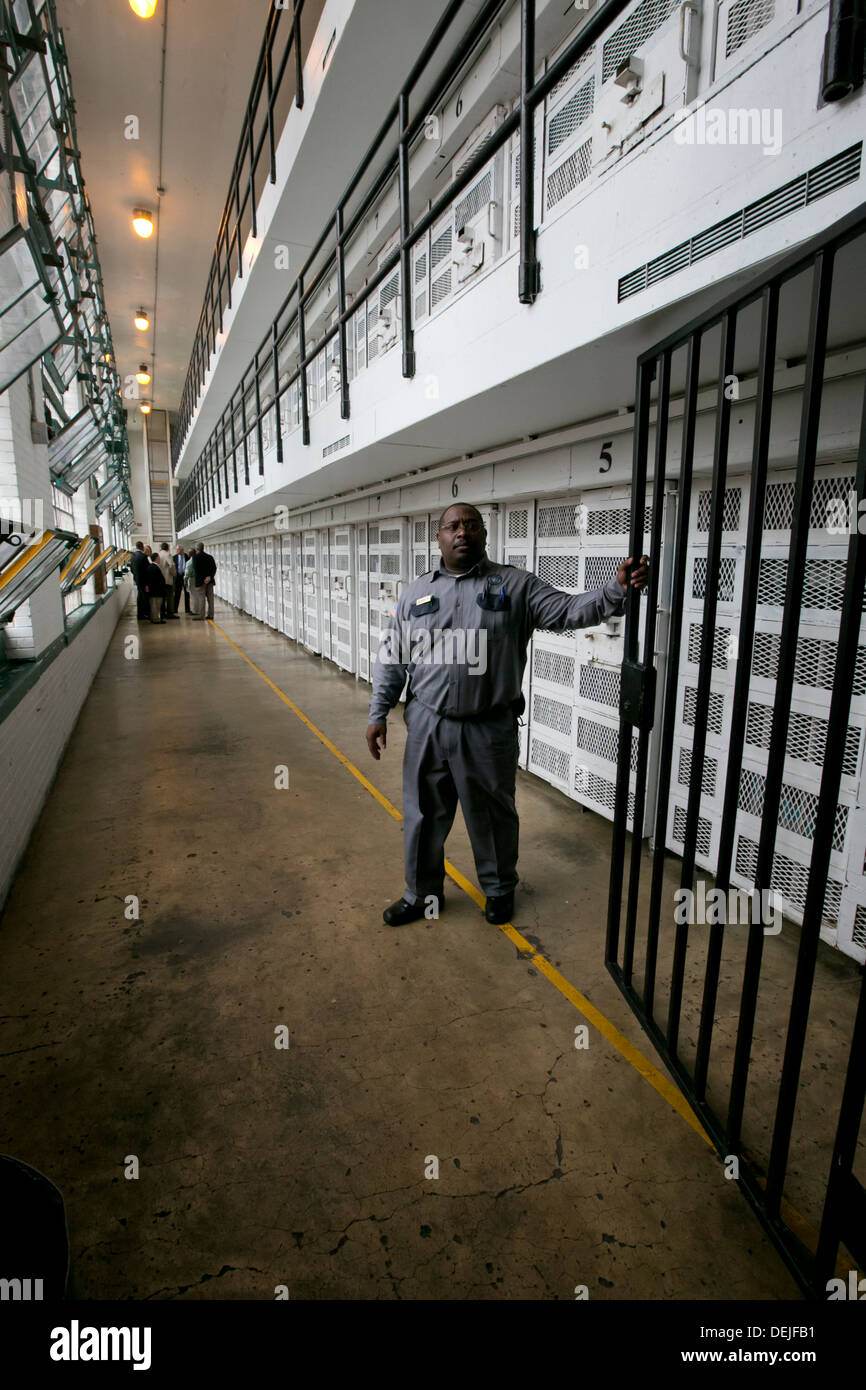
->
<box><xmin>644</xmin><ymin>334</ymin><xmax>702</xmax><ymax>1019</ymax></box>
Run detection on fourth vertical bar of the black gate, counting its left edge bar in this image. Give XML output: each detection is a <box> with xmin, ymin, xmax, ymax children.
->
<box><xmin>663</xmin><ymin>310</ymin><xmax>737</xmax><ymax>1054</ymax></box>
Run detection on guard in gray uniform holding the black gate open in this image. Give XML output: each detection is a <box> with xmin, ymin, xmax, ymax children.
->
<box><xmin>367</xmin><ymin>503</ymin><xmax>649</xmax><ymax>927</ymax></box>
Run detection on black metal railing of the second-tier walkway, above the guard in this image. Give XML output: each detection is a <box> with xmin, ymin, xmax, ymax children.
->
<box><xmin>175</xmin><ymin>0</ymin><xmax>631</xmax><ymax>528</ymax></box>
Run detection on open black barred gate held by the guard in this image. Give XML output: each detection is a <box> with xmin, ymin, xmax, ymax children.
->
<box><xmin>606</xmin><ymin>207</ymin><xmax>866</xmax><ymax>1298</ymax></box>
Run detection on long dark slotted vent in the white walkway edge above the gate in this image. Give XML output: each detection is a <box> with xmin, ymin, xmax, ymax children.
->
<box><xmin>619</xmin><ymin>143</ymin><xmax>863</xmax><ymax>303</ymax></box>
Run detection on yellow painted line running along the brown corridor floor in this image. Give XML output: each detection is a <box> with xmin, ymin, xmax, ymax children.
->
<box><xmin>209</xmin><ymin>619</ymin><xmax>714</xmax><ymax>1148</ymax></box>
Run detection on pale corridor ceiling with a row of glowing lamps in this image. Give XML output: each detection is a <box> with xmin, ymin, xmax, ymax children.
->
<box><xmin>56</xmin><ymin>0</ymin><xmax>270</xmax><ymax>431</ymax></box>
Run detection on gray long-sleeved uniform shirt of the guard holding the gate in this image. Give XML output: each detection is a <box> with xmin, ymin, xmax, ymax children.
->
<box><xmin>370</xmin><ymin>556</ymin><xmax>626</xmax><ymax>724</ymax></box>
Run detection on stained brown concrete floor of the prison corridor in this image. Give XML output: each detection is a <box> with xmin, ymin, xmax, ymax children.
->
<box><xmin>0</xmin><ymin>602</ymin><xmax>798</xmax><ymax>1300</ymax></box>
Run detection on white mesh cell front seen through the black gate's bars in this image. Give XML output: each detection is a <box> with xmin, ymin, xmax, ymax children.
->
<box><xmin>667</xmin><ymin>464</ymin><xmax>866</xmax><ymax>962</ymax></box>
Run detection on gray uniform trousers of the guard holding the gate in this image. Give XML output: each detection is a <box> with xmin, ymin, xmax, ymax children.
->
<box><xmin>403</xmin><ymin>699</ymin><xmax>520</xmax><ymax>902</ymax></box>
